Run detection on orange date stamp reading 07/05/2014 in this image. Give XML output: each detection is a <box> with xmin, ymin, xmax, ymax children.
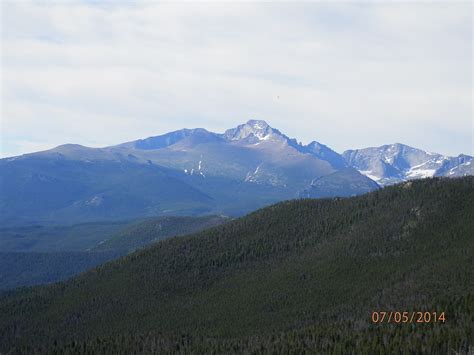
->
<box><xmin>371</xmin><ymin>311</ymin><xmax>446</xmax><ymax>324</ymax></box>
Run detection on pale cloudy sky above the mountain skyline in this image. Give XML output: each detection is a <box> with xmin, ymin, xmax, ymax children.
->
<box><xmin>0</xmin><ymin>0</ymin><xmax>474</xmax><ymax>157</ymax></box>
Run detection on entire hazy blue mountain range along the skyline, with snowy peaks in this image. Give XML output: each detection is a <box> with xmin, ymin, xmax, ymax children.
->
<box><xmin>0</xmin><ymin>120</ymin><xmax>474</xmax><ymax>225</ymax></box>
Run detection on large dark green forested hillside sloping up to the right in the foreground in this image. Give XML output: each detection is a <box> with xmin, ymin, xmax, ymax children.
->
<box><xmin>0</xmin><ymin>177</ymin><xmax>474</xmax><ymax>353</ymax></box>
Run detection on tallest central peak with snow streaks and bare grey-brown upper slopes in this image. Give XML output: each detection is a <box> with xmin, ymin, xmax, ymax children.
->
<box><xmin>118</xmin><ymin>120</ymin><xmax>336</xmax><ymax>188</ymax></box>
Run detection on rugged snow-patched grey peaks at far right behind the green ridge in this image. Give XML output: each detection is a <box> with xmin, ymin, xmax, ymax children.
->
<box><xmin>342</xmin><ymin>143</ymin><xmax>474</xmax><ymax>185</ymax></box>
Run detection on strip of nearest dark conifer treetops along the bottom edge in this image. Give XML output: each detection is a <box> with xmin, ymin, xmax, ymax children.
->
<box><xmin>12</xmin><ymin>295</ymin><xmax>474</xmax><ymax>355</ymax></box>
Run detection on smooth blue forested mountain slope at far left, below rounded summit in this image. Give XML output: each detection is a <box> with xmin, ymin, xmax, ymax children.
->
<box><xmin>0</xmin><ymin>156</ymin><xmax>213</xmax><ymax>224</ymax></box>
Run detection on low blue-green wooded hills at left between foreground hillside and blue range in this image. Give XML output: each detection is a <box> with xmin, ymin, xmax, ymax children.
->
<box><xmin>0</xmin><ymin>216</ymin><xmax>229</xmax><ymax>290</ymax></box>
